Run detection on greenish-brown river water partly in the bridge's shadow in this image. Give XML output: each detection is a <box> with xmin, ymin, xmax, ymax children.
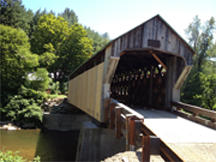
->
<box><xmin>0</xmin><ymin>129</ymin><xmax>79</xmax><ymax>162</ymax></box>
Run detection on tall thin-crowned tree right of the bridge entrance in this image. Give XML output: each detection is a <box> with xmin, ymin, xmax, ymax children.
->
<box><xmin>181</xmin><ymin>16</ymin><xmax>215</xmax><ymax>106</ymax></box>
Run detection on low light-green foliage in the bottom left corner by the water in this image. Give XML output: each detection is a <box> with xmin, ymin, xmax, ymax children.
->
<box><xmin>0</xmin><ymin>149</ymin><xmax>40</xmax><ymax>162</ymax></box>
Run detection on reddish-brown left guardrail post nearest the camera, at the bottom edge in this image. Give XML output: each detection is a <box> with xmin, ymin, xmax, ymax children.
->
<box><xmin>142</xmin><ymin>136</ymin><xmax>151</xmax><ymax>162</ymax></box>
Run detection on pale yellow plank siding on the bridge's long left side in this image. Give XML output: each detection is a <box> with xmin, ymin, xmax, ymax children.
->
<box><xmin>68</xmin><ymin>63</ymin><xmax>104</xmax><ymax>121</ymax></box>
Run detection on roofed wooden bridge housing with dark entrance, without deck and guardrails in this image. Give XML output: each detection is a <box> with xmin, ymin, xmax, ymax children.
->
<box><xmin>68</xmin><ymin>15</ymin><xmax>195</xmax><ymax>122</ymax></box>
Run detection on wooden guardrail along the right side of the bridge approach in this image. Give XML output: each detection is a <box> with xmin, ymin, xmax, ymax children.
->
<box><xmin>170</xmin><ymin>101</ymin><xmax>216</xmax><ymax>129</ymax></box>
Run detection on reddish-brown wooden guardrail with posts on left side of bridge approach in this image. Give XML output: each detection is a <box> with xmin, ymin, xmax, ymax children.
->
<box><xmin>104</xmin><ymin>98</ymin><xmax>183</xmax><ymax>162</ymax></box>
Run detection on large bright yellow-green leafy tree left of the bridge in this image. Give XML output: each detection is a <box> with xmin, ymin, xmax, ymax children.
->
<box><xmin>31</xmin><ymin>14</ymin><xmax>92</xmax><ymax>90</ymax></box>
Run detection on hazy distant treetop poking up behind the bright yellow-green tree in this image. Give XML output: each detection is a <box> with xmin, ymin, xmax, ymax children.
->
<box><xmin>58</xmin><ymin>8</ymin><xmax>78</xmax><ymax>27</ymax></box>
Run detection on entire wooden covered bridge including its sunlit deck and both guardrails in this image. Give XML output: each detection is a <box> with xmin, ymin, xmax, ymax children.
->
<box><xmin>68</xmin><ymin>15</ymin><xmax>216</xmax><ymax>161</ymax></box>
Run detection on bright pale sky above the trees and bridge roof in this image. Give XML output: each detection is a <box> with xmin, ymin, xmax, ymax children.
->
<box><xmin>22</xmin><ymin>0</ymin><xmax>216</xmax><ymax>40</ymax></box>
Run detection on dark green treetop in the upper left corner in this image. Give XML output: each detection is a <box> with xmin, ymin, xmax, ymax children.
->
<box><xmin>0</xmin><ymin>0</ymin><xmax>33</xmax><ymax>34</ymax></box>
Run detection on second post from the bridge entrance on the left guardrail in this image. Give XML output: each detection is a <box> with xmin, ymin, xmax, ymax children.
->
<box><xmin>115</xmin><ymin>107</ymin><xmax>122</xmax><ymax>139</ymax></box>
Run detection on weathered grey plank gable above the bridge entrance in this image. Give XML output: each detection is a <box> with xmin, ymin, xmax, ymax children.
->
<box><xmin>111</xmin><ymin>16</ymin><xmax>194</xmax><ymax>65</ymax></box>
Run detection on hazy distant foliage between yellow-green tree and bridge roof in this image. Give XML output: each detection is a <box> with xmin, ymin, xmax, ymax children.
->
<box><xmin>84</xmin><ymin>27</ymin><xmax>110</xmax><ymax>53</ymax></box>
